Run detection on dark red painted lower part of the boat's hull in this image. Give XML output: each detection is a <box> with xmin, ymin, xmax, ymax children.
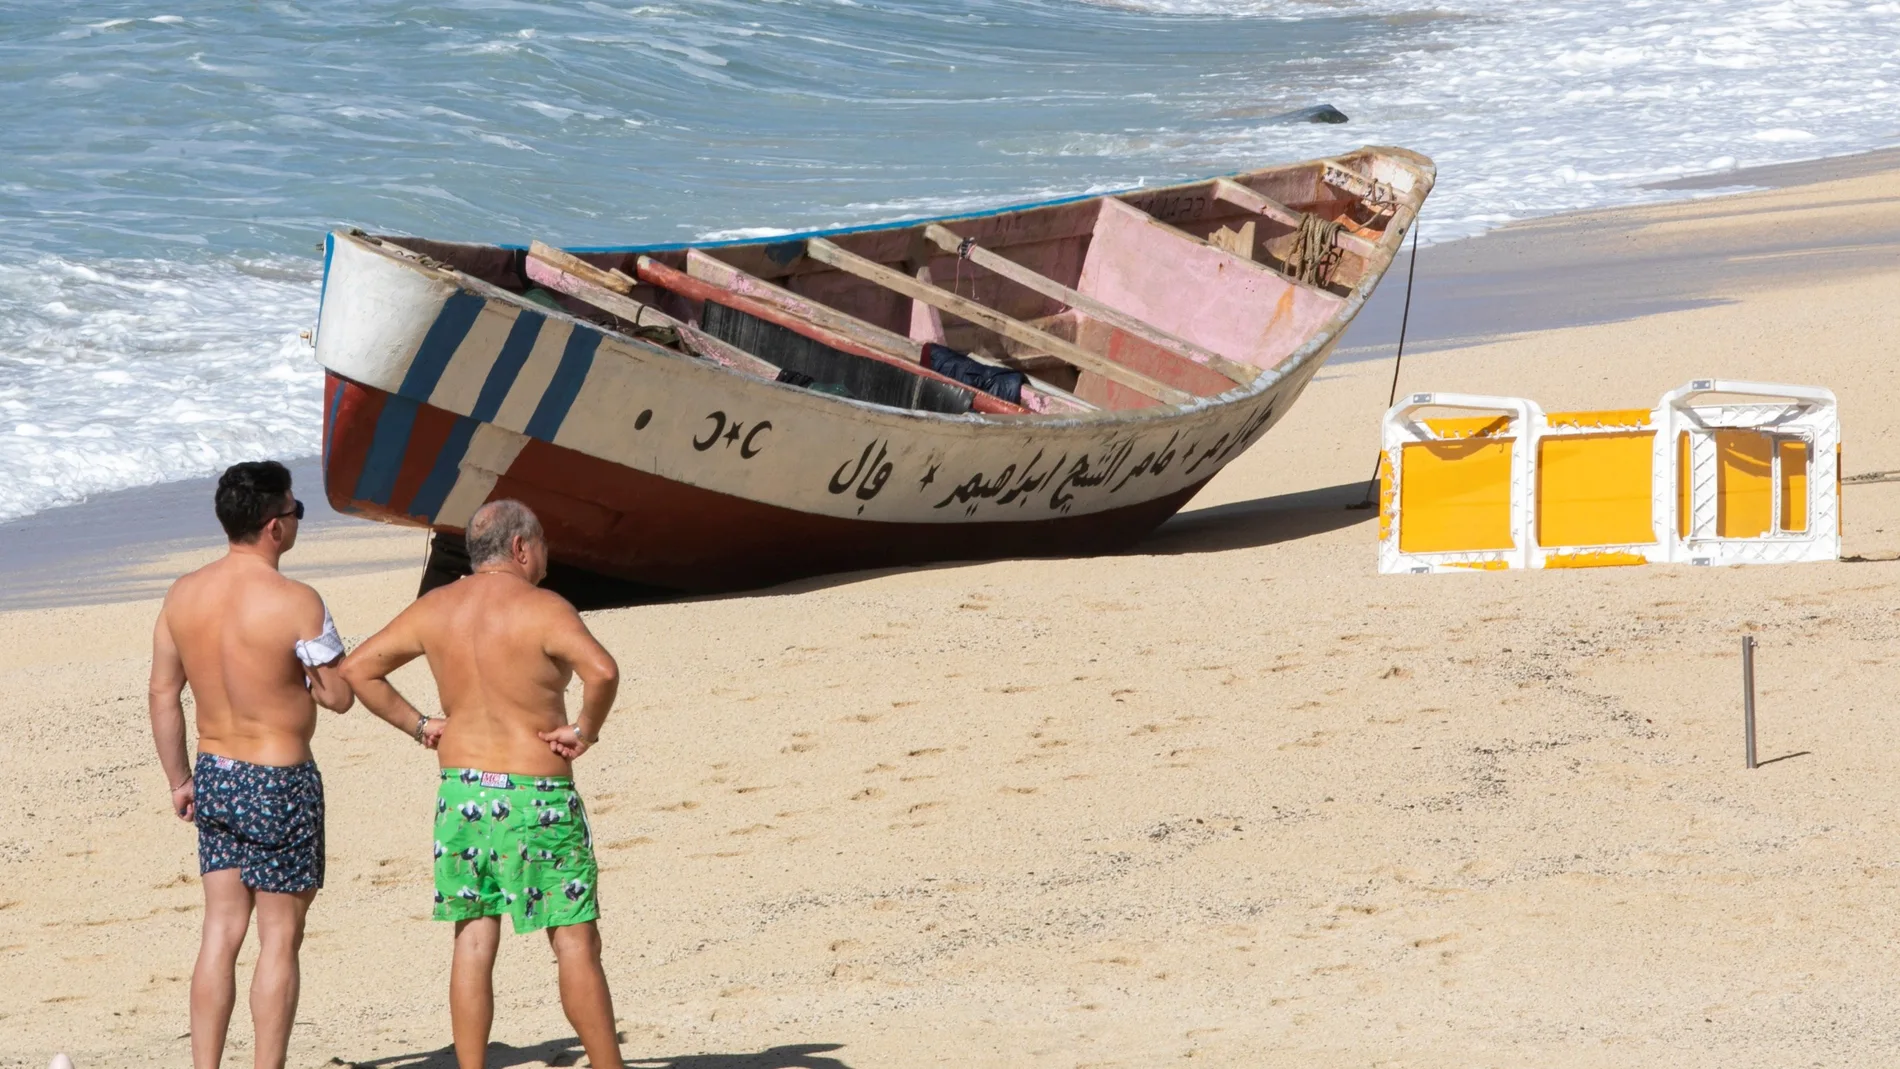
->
<box><xmin>323</xmin><ymin>372</ymin><xmax>1205</xmax><ymax>592</ymax></box>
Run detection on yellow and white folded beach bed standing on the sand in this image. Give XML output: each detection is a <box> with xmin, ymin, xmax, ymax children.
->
<box><xmin>1379</xmin><ymin>380</ymin><xmax>1841</xmax><ymax>573</ymax></box>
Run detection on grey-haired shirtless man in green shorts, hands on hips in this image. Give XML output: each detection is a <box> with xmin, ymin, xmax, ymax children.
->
<box><xmin>344</xmin><ymin>501</ymin><xmax>621</xmax><ymax>1069</ymax></box>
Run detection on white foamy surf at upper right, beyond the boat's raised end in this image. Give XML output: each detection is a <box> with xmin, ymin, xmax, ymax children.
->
<box><xmin>1102</xmin><ymin>0</ymin><xmax>1900</xmax><ymax>241</ymax></box>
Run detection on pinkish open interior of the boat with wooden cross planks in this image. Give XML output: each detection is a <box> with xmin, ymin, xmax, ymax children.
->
<box><xmin>382</xmin><ymin>148</ymin><xmax>1431</xmax><ymax>418</ymax></box>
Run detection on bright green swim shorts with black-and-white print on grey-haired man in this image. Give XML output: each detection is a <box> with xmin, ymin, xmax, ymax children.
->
<box><xmin>435</xmin><ymin>769</ymin><xmax>600</xmax><ymax>934</ymax></box>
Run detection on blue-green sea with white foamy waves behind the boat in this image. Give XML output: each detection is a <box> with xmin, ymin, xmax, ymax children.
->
<box><xmin>0</xmin><ymin>0</ymin><xmax>1900</xmax><ymax>518</ymax></box>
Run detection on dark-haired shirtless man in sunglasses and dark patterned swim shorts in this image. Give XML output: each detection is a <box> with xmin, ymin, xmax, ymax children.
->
<box><xmin>150</xmin><ymin>461</ymin><xmax>352</xmax><ymax>1069</ymax></box>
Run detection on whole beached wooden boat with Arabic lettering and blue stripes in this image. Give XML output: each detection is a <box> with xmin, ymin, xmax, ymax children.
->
<box><xmin>315</xmin><ymin>148</ymin><xmax>1435</xmax><ymax>591</ymax></box>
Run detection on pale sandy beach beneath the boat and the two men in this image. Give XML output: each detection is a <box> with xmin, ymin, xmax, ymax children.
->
<box><xmin>11</xmin><ymin>161</ymin><xmax>1900</xmax><ymax>1069</ymax></box>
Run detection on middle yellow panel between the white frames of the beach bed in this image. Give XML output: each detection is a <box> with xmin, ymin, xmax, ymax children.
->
<box><xmin>1537</xmin><ymin>431</ymin><xmax>1657</xmax><ymax>547</ymax></box>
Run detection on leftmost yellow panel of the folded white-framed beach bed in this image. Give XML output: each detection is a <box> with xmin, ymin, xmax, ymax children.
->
<box><xmin>1398</xmin><ymin>439</ymin><xmax>1514</xmax><ymax>553</ymax></box>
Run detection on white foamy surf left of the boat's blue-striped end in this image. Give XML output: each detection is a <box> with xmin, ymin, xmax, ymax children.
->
<box><xmin>0</xmin><ymin>256</ymin><xmax>323</xmax><ymax>520</ymax></box>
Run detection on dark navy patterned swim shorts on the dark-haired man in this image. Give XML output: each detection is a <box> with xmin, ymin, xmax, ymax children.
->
<box><xmin>192</xmin><ymin>754</ymin><xmax>323</xmax><ymax>894</ymax></box>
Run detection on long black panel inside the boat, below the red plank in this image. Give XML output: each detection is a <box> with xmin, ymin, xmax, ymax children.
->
<box><xmin>699</xmin><ymin>300</ymin><xmax>969</xmax><ymax>416</ymax></box>
